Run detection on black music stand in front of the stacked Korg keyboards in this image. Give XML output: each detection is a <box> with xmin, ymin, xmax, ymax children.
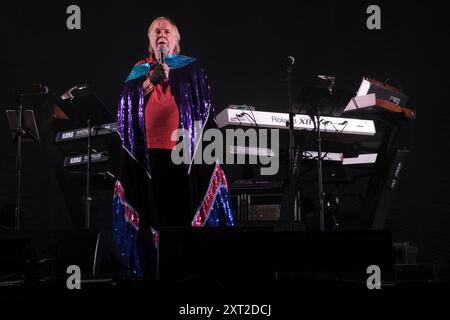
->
<box><xmin>56</xmin><ymin>85</ymin><xmax>115</xmax><ymax>229</ymax></box>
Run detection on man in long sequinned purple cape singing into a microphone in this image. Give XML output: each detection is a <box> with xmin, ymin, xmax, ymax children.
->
<box><xmin>113</xmin><ymin>17</ymin><xmax>235</xmax><ymax>275</ymax></box>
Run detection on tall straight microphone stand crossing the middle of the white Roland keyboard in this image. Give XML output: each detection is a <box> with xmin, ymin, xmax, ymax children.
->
<box><xmin>287</xmin><ymin>57</ymin><xmax>305</xmax><ymax>231</ymax></box>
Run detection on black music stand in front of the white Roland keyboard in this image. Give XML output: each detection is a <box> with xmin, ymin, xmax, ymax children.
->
<box><xmin>297</xmin><ymin>85</ymin><xmax>353</xmax><ymax>231</ymax></box>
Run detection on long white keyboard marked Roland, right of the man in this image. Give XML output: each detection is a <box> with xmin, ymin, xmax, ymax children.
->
<box><xmin>216</xmin><ymin>108</ymin><xmax>376</xmax><ymax>136</ymax></box>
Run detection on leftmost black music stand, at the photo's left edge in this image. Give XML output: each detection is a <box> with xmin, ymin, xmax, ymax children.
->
<box><xmin>6</xmin><ymin>109</ymin><xmax>40</xmax><ymax>232</ymax></box>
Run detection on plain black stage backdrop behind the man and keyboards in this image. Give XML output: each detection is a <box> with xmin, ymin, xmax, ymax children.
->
<box><xmin>0</xmin><ymin>0</ymin><xmax>450</xmax><ymax>278</ymax></box>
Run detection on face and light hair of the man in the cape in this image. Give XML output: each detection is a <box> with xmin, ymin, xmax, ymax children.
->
<box><xmin>149</xmin><ymin>20</ymin><xmax>177</xmax><ymax>55</ymax></box>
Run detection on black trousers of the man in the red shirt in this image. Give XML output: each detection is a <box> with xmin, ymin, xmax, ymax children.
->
<box><xmin>148</xmin><ymin>149</ymin><xmax>193</xmax><ymax>227</ymax></box>
